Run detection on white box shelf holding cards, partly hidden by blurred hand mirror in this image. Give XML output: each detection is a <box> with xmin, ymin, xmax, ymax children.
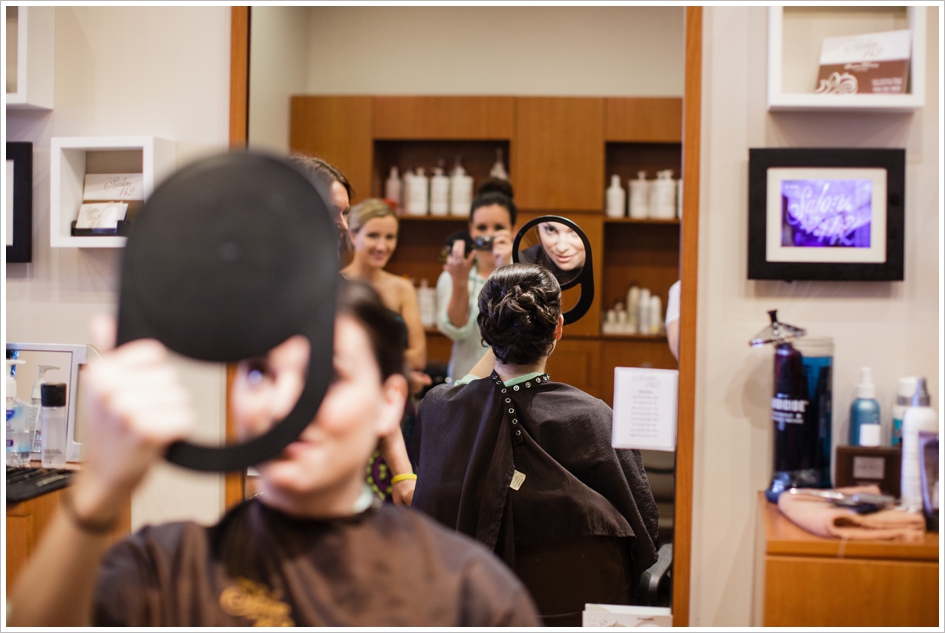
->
<box><xmin>49</xmin><ymin>136</ymin><xmax>177</xmax><ymax>248</ymax></box>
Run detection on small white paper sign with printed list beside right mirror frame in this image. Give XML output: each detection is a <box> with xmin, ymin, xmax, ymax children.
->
<box><xmin>612</xmin><ymin>367</ymin><xmax>679</xmax><ymax>451</ymax></box>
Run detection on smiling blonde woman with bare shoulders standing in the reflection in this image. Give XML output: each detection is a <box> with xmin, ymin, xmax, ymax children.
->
<box><xmin>341</xmin><ymin>198</ymin><xmax>431</xmax><ymax>505</ymax></box>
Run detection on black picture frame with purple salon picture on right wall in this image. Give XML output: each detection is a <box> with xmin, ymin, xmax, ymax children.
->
<box><xmin>748</xmin><ymin>148</ymin><xmax>906</xmax><ymax>281</ymax></box>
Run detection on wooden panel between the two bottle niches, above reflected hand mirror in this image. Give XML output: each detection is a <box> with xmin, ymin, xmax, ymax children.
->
<box><xmin>509</xmin><ymin>97</ymin><xmax>604</xmax><ymax>214</ymax></box>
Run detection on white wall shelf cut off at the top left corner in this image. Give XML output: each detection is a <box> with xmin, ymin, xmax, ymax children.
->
<box><xmin>4</xmin><ymin>6</ymin><xmax>56</xmax><ymax>110</ymax></box>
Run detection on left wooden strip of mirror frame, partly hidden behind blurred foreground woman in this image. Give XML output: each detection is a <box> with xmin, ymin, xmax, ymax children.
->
<box><xmin>223</xmin><ymin>7</ymin><xmax>249</xmax><ymax>510</ymax></box>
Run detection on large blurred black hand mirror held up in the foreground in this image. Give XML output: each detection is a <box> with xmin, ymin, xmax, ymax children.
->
<box><xmin>117</xmin><ymin>152</ymin><xmax>338</xmax><ymax>471</ymax></box>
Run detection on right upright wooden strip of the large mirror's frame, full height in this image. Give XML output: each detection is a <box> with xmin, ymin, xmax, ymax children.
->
<box><xmin>673</xmin><ymin>7</ymin><xmax>702</xmax><ymax>626</ymax></box>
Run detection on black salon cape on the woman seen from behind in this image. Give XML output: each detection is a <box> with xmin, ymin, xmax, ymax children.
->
<box><xmin>410</xmin><ymin>373</ymin><xmax>658</xmax><ymax>577</ymax></box>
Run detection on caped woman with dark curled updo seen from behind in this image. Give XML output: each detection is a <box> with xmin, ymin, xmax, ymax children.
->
<box><xmin>410</xmin><ymin>264</ymin><xmax>659</xmax><ymax>626</ymax></box>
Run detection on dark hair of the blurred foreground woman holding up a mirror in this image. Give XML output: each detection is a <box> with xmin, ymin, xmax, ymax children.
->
<box><xmin>336</xmin><ymin>278</ymin><xmax>407</xmax><ymax>380</ymax></box>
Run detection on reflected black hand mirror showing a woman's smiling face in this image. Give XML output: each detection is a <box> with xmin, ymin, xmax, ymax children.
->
<box><xmin>512</xmin><ymin>215</ymin><xmax>594</xmax><ymax>323</ymax></box>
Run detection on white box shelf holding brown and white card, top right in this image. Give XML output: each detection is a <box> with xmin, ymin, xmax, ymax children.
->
<box><xmin>768</xmin><ymin>6</ymin><xmax>926</xmax><ymax>112</ymax></box>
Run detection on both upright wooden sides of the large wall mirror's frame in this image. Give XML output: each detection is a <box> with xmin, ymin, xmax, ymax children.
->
<box><xmin>224</xmin><ymin>6</ymin><xmax>702</xmax><ymax>626</ymax></box>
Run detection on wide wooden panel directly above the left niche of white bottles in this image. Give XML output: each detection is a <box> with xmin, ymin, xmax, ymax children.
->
<box><xmin>374</xmin><ymin>96</ymin><xmax>514</xmax><ymax>139</ymax></box>
